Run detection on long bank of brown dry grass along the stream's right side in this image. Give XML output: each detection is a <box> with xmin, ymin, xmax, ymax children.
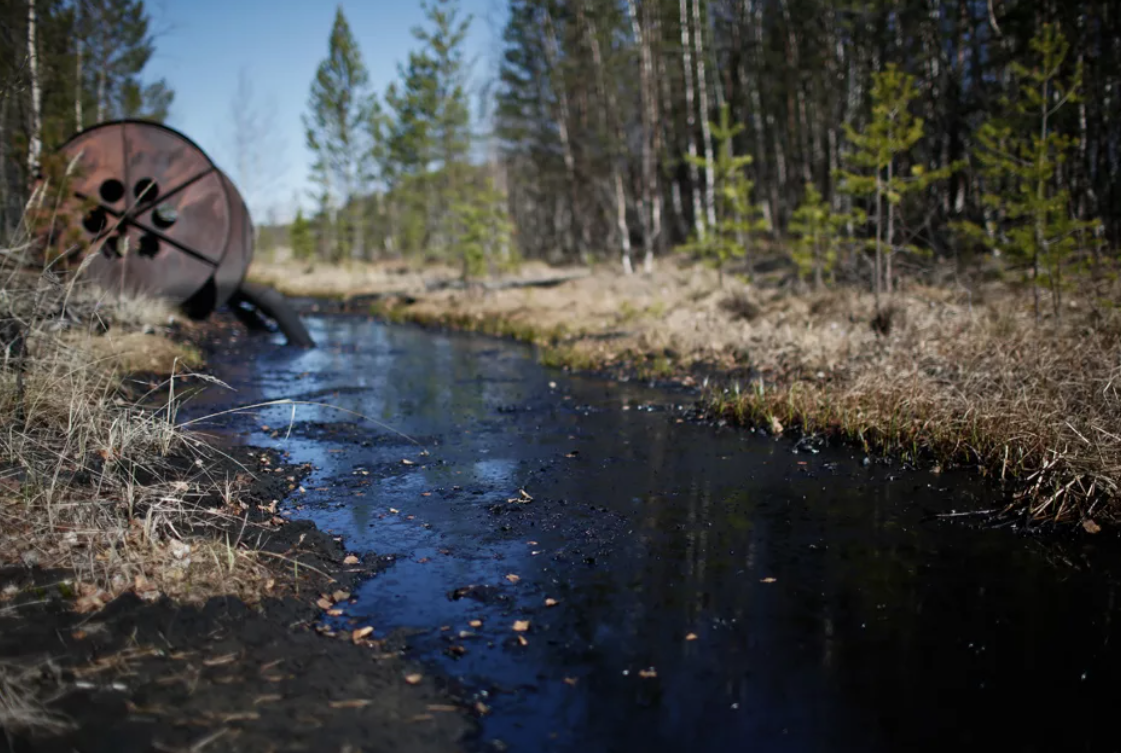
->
<box><xmin>251</xmin><ymin>255</ymin><xmax>1121</xmax><ymax>519</ymax></box>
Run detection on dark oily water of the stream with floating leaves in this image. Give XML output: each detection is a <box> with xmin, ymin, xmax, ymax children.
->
<box><xmin>191</xmin><ymin>317</ymin><xmax>1121</xmax><ymax>753</ymax></box>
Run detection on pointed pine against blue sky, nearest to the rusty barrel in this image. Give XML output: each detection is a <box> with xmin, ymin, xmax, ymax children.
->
<box><xmin>304</xmin><ymin>8</ymin><xmax>374</xmax><ymax>261</ymax></box>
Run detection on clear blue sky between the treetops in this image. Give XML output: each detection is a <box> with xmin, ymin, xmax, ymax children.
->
<box><xmin>145</xmin><ymin>0</ymin><xmax>506</xmax><ymax>223</ymax></box>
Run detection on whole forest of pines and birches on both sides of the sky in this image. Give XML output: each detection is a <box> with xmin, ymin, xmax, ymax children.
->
<box><xmin>0</xmin><ymin>0</ymin><xmax>1121</xmax><ymax>313</ymax></box>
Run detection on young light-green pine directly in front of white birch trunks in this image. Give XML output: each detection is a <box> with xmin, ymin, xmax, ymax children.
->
<box><xmin>680</xmin><ymin>104</ymin><xmax>768</xmax><ymax>286</ymax></box>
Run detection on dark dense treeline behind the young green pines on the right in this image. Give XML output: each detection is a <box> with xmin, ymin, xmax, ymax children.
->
<box><xmin>498</xmin><ymin>0</ymin><xmax>1121</xmax><ymax>272</ymax></box>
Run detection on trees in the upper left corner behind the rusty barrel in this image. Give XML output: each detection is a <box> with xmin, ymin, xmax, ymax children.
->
<box><xmin>0</xmin><ymin>0</ymin><xmax>174</xmax><ymax>238</ymax></box>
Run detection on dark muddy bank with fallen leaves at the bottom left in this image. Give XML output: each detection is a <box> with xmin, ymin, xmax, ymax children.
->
<box><xmin>0</xmin><ymin>319</ymin><xmax>473</xmax><ymax>752</ymax></box>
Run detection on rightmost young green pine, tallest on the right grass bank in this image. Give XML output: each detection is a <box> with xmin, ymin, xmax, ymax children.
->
<box><xmin>961</xmin><ymin>24</ymin><xmax>1101</xmax><ymax>318</ymax></box>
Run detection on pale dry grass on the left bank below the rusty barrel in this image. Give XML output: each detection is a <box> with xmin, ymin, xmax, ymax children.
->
<box><xmin>0</xmin><ymin>215</ymin><xmax>289</xmax><ymax>611</ymax></box>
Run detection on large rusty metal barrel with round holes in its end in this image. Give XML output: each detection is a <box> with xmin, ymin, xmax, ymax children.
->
<box><xmin>46</xmin><ymin>120</ymin><xmax>253</xmax><ymax>318</ymax></box>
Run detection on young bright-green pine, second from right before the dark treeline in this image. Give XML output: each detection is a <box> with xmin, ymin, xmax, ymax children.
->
<box><xmin>840</xmin><ymin>65</ymin><xmax>953</xmax><ymax>312</ymax></box>
